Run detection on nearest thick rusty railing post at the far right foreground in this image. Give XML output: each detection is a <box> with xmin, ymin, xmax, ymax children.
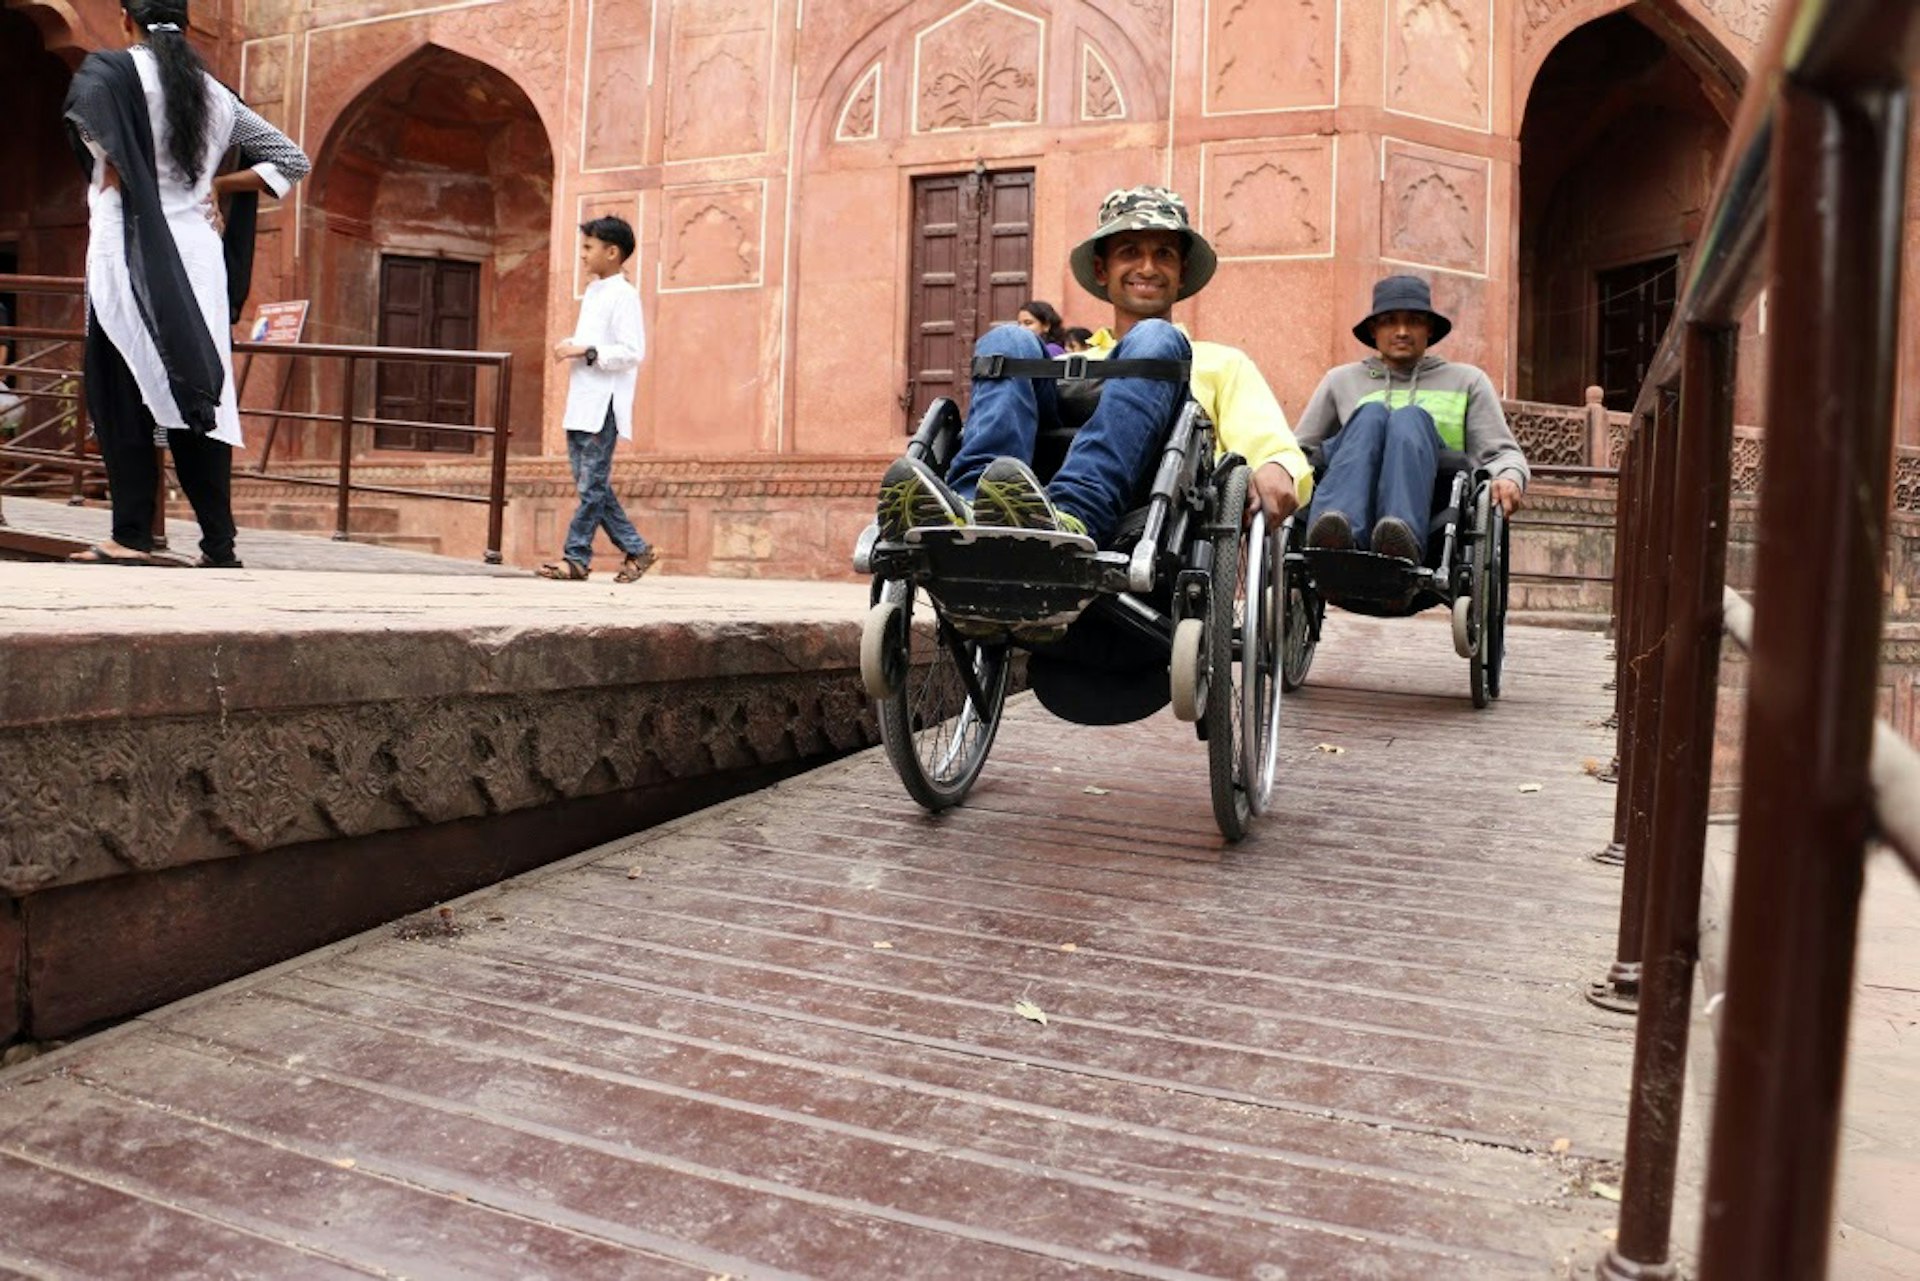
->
<box><xmin>1699</xmin><ymin>77</ymin><xmax>1908</xmax><ymax>1281</ymax></box>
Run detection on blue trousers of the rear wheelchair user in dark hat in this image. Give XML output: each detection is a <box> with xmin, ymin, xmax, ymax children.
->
<box><xmin>1309</xmin><ymin>401</ymin><xmax>1440</xmax><ymax>547</ymax></box>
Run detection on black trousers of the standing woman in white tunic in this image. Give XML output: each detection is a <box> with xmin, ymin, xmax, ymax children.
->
<box><xmin>83</xmin><ymin>317</ymin><xmax>236</xmax><ymax>565</ymax></box>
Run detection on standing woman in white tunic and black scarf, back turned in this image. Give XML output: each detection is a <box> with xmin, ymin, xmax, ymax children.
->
<box><xmin>67</xmin><ymin>0</ymin><xmax>309</xmax><ymax>567</ymax></box>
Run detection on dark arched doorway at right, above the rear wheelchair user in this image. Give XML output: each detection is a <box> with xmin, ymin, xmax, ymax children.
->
<box><xmin>1517</xmin><ymin>12</ymin><xmax>1728</xmax><ymax>409</ymax></box>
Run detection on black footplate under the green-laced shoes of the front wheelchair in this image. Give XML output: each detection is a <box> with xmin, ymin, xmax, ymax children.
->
<box><xmin>894</xmin><ymin>524</ymin><xmax>1127</xmax><ymax>630</ymax></box>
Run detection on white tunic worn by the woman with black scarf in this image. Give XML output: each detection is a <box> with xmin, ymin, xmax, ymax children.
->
<box><xmin>86</xmin><ymin>46</ymin><xmax>298</xmax><ymax>447</ymax></box>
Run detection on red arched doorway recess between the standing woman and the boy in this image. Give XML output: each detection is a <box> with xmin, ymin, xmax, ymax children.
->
<box><xmin>305</xmin><ymin>46</ymin><xmax>553</xmax><ymax>453</ymax></box>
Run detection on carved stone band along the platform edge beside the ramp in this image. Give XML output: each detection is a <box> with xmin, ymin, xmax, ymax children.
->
<box><xmin>0</xmin><ymin>672</ymin><xmax>877</xmax><ymax>893</ymax></box>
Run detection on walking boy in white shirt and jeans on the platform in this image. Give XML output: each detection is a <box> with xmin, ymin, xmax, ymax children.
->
<box><xmin>540</xmin><ymin>215</ymin><xmax>655</xmax><ymax>582</ymax></box>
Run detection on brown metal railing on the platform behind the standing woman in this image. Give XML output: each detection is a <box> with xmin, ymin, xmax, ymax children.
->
<box><xmin>0</xmin><ymin>275</ymin><xmax>513</xmax><ymax>565</ymax></box>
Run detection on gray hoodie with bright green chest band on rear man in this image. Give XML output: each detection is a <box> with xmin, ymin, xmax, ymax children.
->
<box><xmin>1294</xmin><ymin>355</ymin><xmax>1530</xmax><ymax>490</ymax></box>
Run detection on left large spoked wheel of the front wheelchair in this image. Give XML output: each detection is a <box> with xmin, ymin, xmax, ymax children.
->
<box><xmin>875</xmin><ymin>582</ymin><xmax>1010</xmax><ymax>810</ymax></box>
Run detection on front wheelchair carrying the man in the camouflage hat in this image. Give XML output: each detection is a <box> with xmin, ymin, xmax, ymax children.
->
<box><xmin>854</xmin><ymin>399</ymin><xmax>1290</xmax><ymax>841</ymax></box>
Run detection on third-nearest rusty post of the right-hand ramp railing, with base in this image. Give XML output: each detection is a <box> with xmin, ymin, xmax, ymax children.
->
<box><xmin>1586</xmin><ymin>418</ymin><xmax>1674</xmax><ymax>1014</ymax></box>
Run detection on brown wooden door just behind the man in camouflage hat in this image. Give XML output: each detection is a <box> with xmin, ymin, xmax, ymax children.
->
<box><xmin>900</xmin><ymin>169</ymin><xmax>1033</xmax><ymax>432</ymax></box>
